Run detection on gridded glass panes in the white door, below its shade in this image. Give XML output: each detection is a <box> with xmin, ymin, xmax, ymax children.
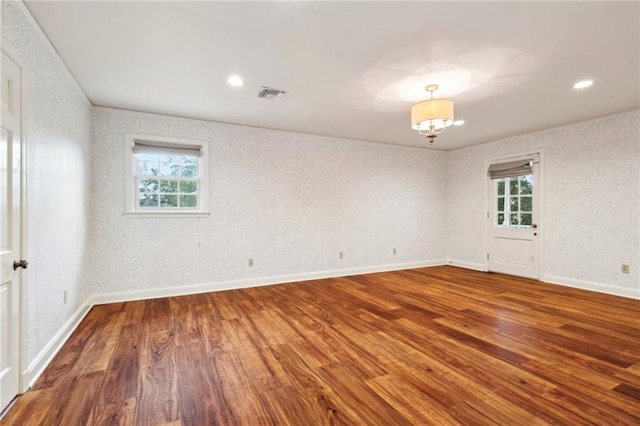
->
<box><xmin>494</xmin><ymin>174</ymin><xmax>533</xmax><ymax>229</ymax></box>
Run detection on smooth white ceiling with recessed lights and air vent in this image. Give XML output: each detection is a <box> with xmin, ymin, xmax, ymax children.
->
<box><xmin>25</xmin><ymin>1</ymin><xmax>640</xmax><ymax>150</ymax></box>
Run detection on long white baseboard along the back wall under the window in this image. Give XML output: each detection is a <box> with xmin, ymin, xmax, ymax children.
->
<box><xmin>90</xmin><ymin>260</ymin><xmax>447</xmax><ymax>305</ymax></box>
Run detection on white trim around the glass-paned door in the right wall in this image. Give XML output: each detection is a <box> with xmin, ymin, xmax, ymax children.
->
<box><xmin>483</xmin><ymin>148</ymin><xmax>546</xmax><ymax>281</ymax></box>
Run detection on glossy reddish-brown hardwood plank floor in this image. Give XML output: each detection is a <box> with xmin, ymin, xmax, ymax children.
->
<box><xmin>2</xmin><ymin>266</ymin><xmax>640</xmax><ymax>426</ymax></box>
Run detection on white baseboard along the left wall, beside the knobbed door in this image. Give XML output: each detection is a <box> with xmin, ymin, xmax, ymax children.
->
<box><xmin>21</xmin><ymin>298</ymin><xmax>93</xmax><ymax>392</ymax></box>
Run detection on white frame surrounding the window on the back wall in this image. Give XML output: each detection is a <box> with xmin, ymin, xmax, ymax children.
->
<box><xmin>124</xmin><ymin>133</ymin><xmax>209</xmax><ymax>218</ymax></box>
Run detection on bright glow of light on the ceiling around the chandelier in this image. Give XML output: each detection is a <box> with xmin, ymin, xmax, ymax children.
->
<box><xmin>358</xmin><ymin>41</ymin><xmax>536</xmax><ymax>113</ymax></box>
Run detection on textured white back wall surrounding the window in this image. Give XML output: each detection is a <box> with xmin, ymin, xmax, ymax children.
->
<box><xmin>91</xmin><ymin>108</ymin><xmax>446</xmax><ymax>294</ymax></box>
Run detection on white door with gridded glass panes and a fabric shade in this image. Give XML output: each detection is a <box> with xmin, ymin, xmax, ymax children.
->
<box><xmin>487</xmin><ymin>155</ymin><xmax>540</xmax><ymax>279</ymax></box>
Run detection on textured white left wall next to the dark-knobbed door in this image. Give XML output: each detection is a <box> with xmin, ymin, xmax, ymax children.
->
<box><xmin>2</xmin><ymin>1</ymin><xmax>91</xmax><ymax>363</ymax></box>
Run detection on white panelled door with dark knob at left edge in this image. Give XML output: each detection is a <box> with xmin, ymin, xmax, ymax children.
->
<box><xmin>0</xmin><ymin>50</ymin><xmax>26</xmax><ymax>411</ymax></box>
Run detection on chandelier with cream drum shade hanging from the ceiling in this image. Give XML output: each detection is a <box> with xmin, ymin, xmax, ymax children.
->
<box><xmin>411</xmin><ymin>84</ymin><xmax>453</xmax><ymax>144</ymax></box>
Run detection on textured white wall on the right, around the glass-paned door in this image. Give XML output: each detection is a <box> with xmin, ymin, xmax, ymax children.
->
<box><xmin>447</xmin><ymin>111</ymin><xmax>640</xmax><ymax>289</ymax></box>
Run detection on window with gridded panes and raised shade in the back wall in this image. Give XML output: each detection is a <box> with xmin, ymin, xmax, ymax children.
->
<box><xmin>126</xmin><ymin>134</ymin><xmax>209</xmax><ymax>217</ymax></box>
